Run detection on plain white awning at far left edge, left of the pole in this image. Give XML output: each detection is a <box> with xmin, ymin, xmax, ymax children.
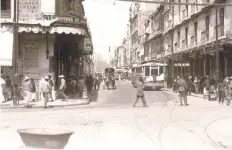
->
<box><xmin>0</xmin><ymin>32</ymin><xmax>13</xmax><ymax>66</ymax></box>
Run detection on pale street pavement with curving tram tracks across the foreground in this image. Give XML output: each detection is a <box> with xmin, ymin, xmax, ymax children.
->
<box><xmin>0</xmin><ymin>81</ymin><xmax>232</xmax><ymax>150</ymax></box>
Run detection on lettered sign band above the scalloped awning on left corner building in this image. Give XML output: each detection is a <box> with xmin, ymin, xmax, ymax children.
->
<box><xmin>42</xmin><ymin>15</ymin><xmax>87</xmax><ymax>25</ymax></box>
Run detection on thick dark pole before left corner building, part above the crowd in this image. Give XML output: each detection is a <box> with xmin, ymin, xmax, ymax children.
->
<box><xmin>12</xmin><ymin>0</ymin><xmax>18</xmax><ymax>74</ymax></box>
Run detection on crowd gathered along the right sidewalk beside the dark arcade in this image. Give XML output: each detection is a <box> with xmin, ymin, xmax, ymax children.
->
<box><xmin>173</xmin><ymin>76</ymin><xmax>232</xmax><ymax>105</ymax></box>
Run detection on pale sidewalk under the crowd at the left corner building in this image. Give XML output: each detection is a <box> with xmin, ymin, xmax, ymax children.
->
<box><xmin>1</xmin><ymin>99</ymin><xmax>89</xmax><ymax>109</ymax></box>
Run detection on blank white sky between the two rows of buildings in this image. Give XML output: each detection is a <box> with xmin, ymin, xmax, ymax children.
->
<box><xmin>83</xmin><ymin>0</ymin><xmax>130</xmax><ymax>61</ymax></box>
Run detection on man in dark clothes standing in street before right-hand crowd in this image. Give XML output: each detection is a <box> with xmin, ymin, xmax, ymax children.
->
<box><xmin>177</xmin><ymin>76</ymin><xmax>189</xmax><ymax>106</ymax></box>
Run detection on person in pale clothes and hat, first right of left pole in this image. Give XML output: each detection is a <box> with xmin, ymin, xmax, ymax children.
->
<box><xmin>23</xmin><ymin>76</ymin><xmax>32</xmax><ymax>106</ymax></box>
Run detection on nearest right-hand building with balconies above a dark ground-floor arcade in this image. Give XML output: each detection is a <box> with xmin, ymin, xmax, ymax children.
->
<box><xmin>164</xmin><ymin>0</ymin><xmax>232</xmax><ymax>84</ymax></box>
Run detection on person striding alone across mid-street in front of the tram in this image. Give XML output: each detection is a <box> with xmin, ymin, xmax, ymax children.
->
<box><xmin>133</xmin><ymin>77</ymin><xmax>147</xmax><ymax>107</ymax></box>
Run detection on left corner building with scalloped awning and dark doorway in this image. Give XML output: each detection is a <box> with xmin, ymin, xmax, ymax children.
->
<box><xmin>0</xmin><ymin>0</ymin><xmax>93</xmax><ymax>87</ymax></box>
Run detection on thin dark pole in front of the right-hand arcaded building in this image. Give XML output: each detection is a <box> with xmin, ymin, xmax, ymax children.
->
<box><xmin>215</xmin><ymin>6</ymin><xmax>220</xmax><ymax>85</ymax></box>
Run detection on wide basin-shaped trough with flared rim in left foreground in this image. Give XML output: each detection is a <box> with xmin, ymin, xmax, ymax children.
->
<box><xmin>17</xmin><ymin>128</ymin><xmax>74</xmax><ymax>149</ymax></box>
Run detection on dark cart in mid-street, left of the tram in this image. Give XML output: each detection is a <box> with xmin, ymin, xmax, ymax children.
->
<box><xmin>103</xmin><ymin>68</ymin><xmax>116</xmax><ymax>90</ymax></box>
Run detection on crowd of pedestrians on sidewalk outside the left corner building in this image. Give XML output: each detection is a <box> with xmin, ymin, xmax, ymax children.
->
<box><xmin>0</xmin><ymin>74</ymin><xmax>100</xmax><ymax>108</ymax></box>
